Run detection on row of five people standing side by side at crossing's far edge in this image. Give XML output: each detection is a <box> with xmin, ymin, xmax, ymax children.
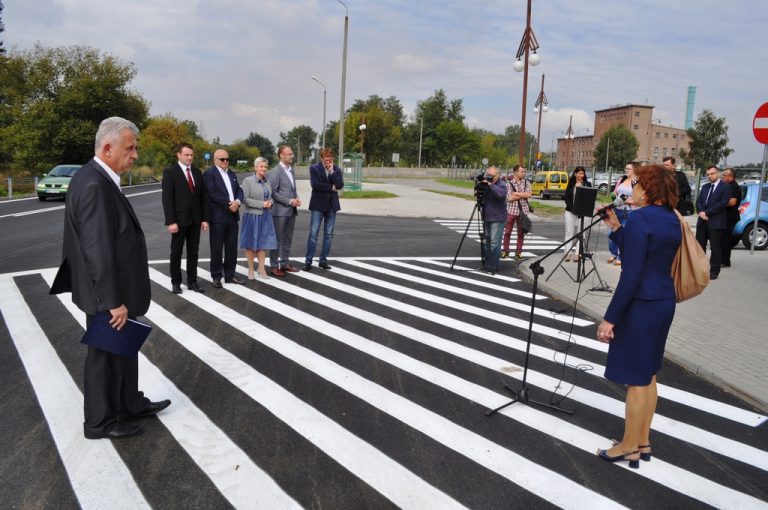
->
<box><xmin>162</xmin><ymin>143</ymin><xmax>344</xmax><ymax>294</ymax></box>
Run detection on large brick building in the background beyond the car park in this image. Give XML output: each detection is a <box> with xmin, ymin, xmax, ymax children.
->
<box><xmin>555</xmin><ymin>104</ymin><xmax>688</xmax><ymax>170</ymax></box>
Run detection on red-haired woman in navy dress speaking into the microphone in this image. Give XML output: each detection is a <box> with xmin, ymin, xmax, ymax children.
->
<box><xmin>597</xmin><ymin>165</ymin><xmax>682</xmax><ymax>468</ymax></box>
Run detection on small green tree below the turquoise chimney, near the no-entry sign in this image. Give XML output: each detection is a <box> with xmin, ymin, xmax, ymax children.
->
<box><xmin>680</xmin><ymin>110</ymin><xmax>733</xmax><ymax>168</ymax></box>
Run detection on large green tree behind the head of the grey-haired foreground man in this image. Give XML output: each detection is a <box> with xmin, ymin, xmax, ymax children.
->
<box><xmin>0</xmin><ymin>45</ymin><xmax>149</xmax><ymax>172</ymax></box>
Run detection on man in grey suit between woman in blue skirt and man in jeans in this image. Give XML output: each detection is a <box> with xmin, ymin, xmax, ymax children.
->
<box><xmin>267</xmin><ymin>145</ymin><xmax>301</xmax><ymax>276</ymax></box>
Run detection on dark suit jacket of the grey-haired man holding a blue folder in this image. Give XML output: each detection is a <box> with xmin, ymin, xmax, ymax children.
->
<box><xmin>51</xmin><ymin>159</ymin><xmax>151</xmax><ymax>317</ymax></box>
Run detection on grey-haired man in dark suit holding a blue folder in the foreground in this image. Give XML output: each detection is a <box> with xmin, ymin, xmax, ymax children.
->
<box><xmin>51</xmin><ymin>117</ymin><xmax>171</xmax><ymax>439</ymax></box>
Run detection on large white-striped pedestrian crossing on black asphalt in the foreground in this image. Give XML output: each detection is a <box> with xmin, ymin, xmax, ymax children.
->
<box><xmin>0</xmin><ymin>257</ymin><xmax>768</xmax><ymax>509</ymax></box>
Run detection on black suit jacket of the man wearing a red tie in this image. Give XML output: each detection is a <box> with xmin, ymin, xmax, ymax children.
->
<box><xmin>162</xmin><ymin>163</ymin><xmax>209</xmax><ymax>227</ymax></box>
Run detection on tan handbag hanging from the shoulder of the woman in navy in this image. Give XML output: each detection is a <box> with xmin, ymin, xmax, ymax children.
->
<box><xmin>672</xmin><ymin>211</ymin><xmax>709</xmax><ymax>303</ymax></box>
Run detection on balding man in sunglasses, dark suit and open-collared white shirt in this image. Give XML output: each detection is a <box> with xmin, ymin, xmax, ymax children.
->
<box><xmin>203</xmin><ymin>149</ymin><xmax>246</xmax><ymax>289</ymax></box>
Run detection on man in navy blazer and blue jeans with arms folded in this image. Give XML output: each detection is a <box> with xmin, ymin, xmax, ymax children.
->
<box><xmin>304</xmin><ymin>148</ymin><xmax>344</xmax><ymax>271</ymax></box>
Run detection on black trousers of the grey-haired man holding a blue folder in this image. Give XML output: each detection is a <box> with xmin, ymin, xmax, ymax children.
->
<box><xmin>83</xmin><ymin>316</ymin><xmax>149</xmax><ymax>434</ymax></box>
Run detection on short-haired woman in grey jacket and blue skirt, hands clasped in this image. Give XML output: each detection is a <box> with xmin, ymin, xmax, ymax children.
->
<box><xmin>240</xmin><ymin>157</ymin><xmax>277</xmax><ymax>280</ymax></box>
